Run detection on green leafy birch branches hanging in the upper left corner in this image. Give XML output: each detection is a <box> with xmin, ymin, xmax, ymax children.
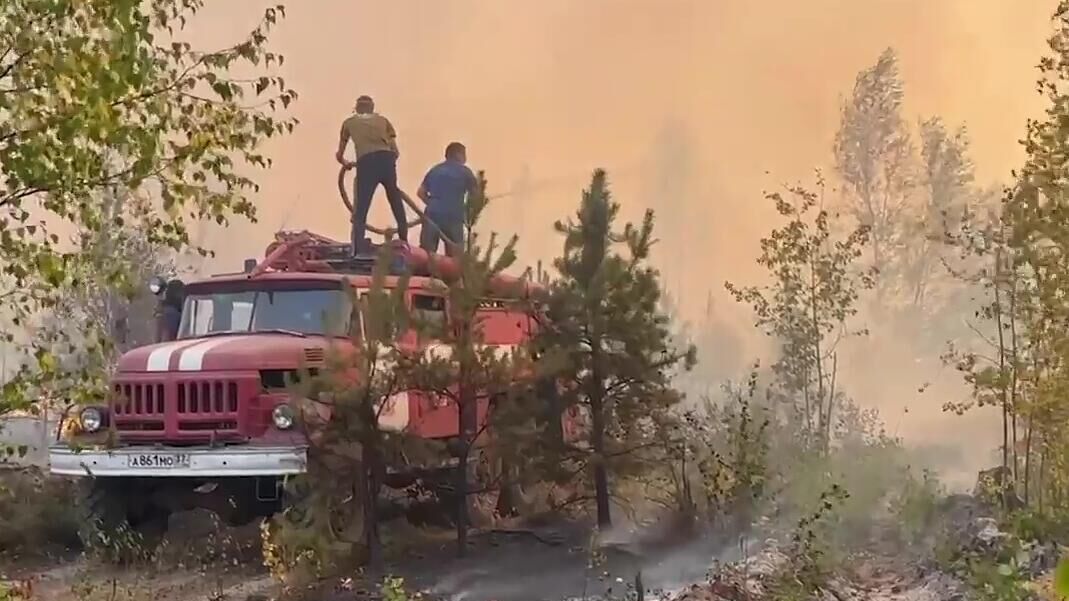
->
<box><xmin>0</xmin><ymin>0</ymin><xmax>296</xmax><ymax>412</ymax></box>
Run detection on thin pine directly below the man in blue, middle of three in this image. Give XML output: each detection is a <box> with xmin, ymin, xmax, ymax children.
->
<box><xmin>407</xmin><ymin>173</ymin><xmax>524</xmax><ymax>556</ymax></box>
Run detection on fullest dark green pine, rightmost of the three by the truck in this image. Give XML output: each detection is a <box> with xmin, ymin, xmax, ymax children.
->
<box><xmin>535</xmin><ymin>170</ymin><xmax>695</xmax><ymax>526</ymax></box>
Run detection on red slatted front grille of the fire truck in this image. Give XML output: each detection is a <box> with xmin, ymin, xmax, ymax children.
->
<box><xmin>111</xmin><ymin>374</ymin><xmax>260</xmax><ymax>442</ymax></box>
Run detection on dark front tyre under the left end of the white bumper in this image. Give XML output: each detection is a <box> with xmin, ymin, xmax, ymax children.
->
<box><xmin>78</xmin><ymin>478</ymin><xmax>170</xmax><ymax>564</ymax></box>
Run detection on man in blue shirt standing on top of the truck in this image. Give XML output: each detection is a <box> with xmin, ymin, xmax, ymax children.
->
<box><xmin>416</xmin><ymin>142</ymin><xmax>479</xmax><ymax>257</ymax></box>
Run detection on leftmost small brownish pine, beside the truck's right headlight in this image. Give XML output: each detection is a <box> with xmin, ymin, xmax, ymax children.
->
<box><xmin>271</xmin><ymin>247</ymin><xmax>413</xmax><ymax>569</ymax></box>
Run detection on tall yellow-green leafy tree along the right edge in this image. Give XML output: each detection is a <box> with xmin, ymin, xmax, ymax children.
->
<box><xmin>946</xmin><ymin>1</ymin><xmax>1069</xmax><ymax>511</ymax></box>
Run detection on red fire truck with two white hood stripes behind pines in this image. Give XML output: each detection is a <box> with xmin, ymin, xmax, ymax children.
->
<box><xmin>49</xmin><ymin>232</ymin><xmax>572</xmax><ymax>540</ymax></box>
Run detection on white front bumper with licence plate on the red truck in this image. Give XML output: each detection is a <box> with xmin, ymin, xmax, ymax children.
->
<box><xmin>48</xmin><ymin>445</ymin><xmax>308</xmax><ymax>478</ymax></box>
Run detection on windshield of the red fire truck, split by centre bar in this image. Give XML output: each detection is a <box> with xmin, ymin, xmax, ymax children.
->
<box><xmin>179</xmin><ymin>290</ymin><xmax>348</xmax><ymax>338</ymax></box>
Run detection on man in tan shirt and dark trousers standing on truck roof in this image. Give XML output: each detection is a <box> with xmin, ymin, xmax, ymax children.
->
<box><xmin>335</xmin><ymin>96</ymin><xmax>408</xmax><ymax>255</ymax></box>
